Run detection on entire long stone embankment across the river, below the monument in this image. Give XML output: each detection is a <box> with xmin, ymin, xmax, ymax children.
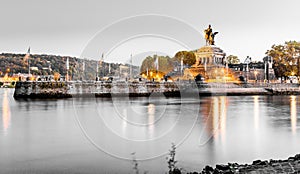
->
<box><xmin>14</xmin><ymin>81</ymin><xmax>300</xmax><ymax>99</ymax></box>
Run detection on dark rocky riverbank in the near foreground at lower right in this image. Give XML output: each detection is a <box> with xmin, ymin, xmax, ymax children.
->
<box><xmin>196</xmin><ymin>154</ymin><xmax>300</xmax><ymax>174</ymax></box>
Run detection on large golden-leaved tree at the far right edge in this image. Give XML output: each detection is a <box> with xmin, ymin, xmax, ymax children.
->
<box><xmin>266</xmin><ymin>41</ymin><xmax>300</xmax><ymax>77</ymax></box>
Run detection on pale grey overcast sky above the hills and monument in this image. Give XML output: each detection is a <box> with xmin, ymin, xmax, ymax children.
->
<box><xmin>0</xmin><ymin>0</ymin><xmax>300</xmax><ymax>64</ymax></box>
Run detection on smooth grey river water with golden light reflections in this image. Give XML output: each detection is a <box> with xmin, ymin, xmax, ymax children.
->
<box><xmin>0</xmin><ymin>89</ymin><xmax>300</xmax><ymax>173</ymax></box>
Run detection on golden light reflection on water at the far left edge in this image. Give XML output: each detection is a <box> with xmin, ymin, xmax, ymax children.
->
<box><xmin>2</xmin><ymin>90</ymin><xmax>11</xmax><ymax>134</ymax></box>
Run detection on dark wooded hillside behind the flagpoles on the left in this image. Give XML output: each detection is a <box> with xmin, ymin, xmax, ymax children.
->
<box><xmin>0</xmin><ymin>53</ymin><xmax>138</xmax><ymax>80</ymax></box>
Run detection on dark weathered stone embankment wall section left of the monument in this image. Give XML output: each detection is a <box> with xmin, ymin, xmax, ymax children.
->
<box><xmin>14</xmin><ymin>82</ymin><xmax>188</xmax><ymax>99</ymax></box>
